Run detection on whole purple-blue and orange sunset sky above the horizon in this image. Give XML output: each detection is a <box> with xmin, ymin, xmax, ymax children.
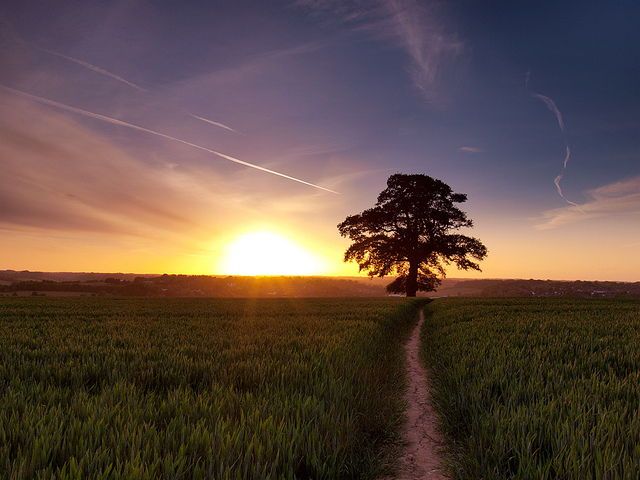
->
<box><xmin>0</xmin><ymin>0</ymin><xmax>640</xmax><ymax>281</ymax></box>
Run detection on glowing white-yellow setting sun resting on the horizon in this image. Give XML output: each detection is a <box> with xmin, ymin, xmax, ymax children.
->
<box><xmin>225</xmin><ymin>231</ymin><xmax>320</xmax><ymax>275</ymax></box>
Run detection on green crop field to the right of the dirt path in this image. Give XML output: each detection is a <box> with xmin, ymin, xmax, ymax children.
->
<box><xmin>422</xmin><ymin>298</ymin><xmax>640</xmax><ymax>480</ymax></box>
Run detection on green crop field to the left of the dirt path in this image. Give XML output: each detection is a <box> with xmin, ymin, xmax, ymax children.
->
<box><xmin>0</xmin><ymin>297</ymin><xmax>420</xmax><ymax>479</ymax></box>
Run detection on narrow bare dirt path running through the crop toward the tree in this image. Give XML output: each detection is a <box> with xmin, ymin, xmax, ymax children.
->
<box><xmin>395</xmin><ymin>311</ymin><xmax>446</xmax><ymax>480</ymax></box>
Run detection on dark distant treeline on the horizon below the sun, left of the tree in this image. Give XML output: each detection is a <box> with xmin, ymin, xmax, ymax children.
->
<box><xmin>0</xmin><ymin>274</ymin><xmax>386</xmax><ymax>297</ymax></box>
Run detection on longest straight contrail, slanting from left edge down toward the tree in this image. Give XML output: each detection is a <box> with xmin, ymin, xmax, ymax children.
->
<box><xmin>0</xmin><ymin>84</ymin><xmax>340</xmax><ymax>195</ymax></box>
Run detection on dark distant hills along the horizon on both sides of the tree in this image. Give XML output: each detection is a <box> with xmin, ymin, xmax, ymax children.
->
<box><xmin>0</xmin><ymin>270</ymin><xmax>640</xmax><ymax>297</ymax></box>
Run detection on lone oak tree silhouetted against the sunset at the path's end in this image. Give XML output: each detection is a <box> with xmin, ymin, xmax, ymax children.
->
<box><xmin>338</xmin><ymin>173</ymin><xmax>487</xmax><ymax>297</ymax></box>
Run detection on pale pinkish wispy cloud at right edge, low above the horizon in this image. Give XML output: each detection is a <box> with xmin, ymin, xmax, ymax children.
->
<box><xmin>537</xmin><ymin>176</ymin><xmax>640</xmax><ymax>230</ymax></box>
